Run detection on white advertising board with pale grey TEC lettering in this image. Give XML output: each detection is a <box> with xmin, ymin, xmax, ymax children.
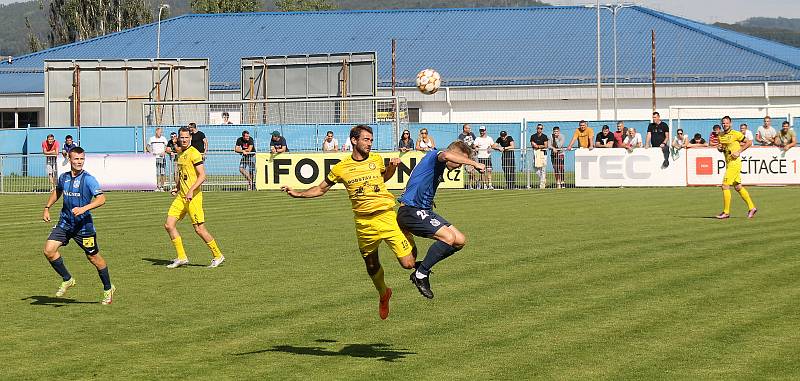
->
<box><xmin>575</xmin><ymin>148</ymin><xmax>686</xmax><ymax>187</ymax></box>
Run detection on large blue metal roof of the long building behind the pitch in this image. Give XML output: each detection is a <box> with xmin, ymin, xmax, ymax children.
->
<box><xmin>0</xmin><ymin>6</ymin><xmax>800</xmax><ymax>93</ymax></box>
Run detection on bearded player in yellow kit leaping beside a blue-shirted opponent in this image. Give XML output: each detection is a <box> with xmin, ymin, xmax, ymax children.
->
<box><xmin>281</xmin><ymin>125</ymin><xmax>416</xmax><ymax>319</ymax></box>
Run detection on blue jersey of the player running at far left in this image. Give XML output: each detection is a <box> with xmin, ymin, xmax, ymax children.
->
<box><xmin>56</xmin><ymin>171</ymin><xmax>103</xmax><ymax>236</ymax></box>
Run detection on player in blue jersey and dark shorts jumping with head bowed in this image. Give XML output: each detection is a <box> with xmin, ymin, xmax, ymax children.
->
<box><xmin>397</xmin><ymin>141</ymin><xmax>486</xmax><ymax>299</ymax></box>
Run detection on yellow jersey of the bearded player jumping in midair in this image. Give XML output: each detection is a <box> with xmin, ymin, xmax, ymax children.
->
<box><xmin>326</xmin><ymin>153</ymin><xmax>394</xmax><ymax>215</ymax></box>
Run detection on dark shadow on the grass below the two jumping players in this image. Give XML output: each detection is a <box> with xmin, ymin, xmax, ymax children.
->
<box><xmin>235</xmin><ymin>339</ymin><xmax>416</xmax><ymax>362</ymax></box>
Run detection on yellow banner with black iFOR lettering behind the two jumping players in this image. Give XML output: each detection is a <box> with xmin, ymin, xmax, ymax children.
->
<box><xmin>256</xmin><ymin>151</ymin><xmax>464</xmax><ymax>190</ymax></box>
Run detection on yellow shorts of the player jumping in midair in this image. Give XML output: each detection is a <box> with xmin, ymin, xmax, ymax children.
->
<box><xmin>356</xmin><ymin>209</ymin><xmax>414</xmax><ymax>258</ymax></box>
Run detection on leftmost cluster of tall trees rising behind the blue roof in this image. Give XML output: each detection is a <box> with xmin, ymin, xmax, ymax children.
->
<box><xmin>48</xmin><ymin>0</ymin><xmax>153</xmax><ymax>46</ymax></box>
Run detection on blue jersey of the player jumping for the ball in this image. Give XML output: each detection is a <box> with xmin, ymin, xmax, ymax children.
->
<box><xmin>400</xmin><ymin>149</ymin><xmax>447</xmax><ymax>209</ymax></box>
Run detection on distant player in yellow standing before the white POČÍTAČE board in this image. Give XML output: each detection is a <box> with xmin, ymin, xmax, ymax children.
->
<box><xmin>717</xmin><ymin>116</ymin><xmax>758</xmax><ymax>220</ymax></box>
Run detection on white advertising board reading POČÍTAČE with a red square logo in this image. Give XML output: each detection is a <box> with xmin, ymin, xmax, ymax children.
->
<box><xmin>686</xmin><ymin>147</ymin><xmax>800</xmax><ymax>186</ymax></box>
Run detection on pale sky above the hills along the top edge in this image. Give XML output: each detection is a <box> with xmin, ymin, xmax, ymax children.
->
<box><xmin>0</xmin><ymin>0</ymin><xmax>800</xmax><ymax>24</ymax></box>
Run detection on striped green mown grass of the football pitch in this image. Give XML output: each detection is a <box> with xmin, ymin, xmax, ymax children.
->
<box><xmin>0</xmin><ymin>188</ymin><xmax>800</xmax><ymax>380</ymax></box>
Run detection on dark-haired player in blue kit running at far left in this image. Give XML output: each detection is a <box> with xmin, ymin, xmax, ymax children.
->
<box><xmin>42</xmin><ymin>147</ymin><xmax>116</xmax><ymax>305</ymax></box>
